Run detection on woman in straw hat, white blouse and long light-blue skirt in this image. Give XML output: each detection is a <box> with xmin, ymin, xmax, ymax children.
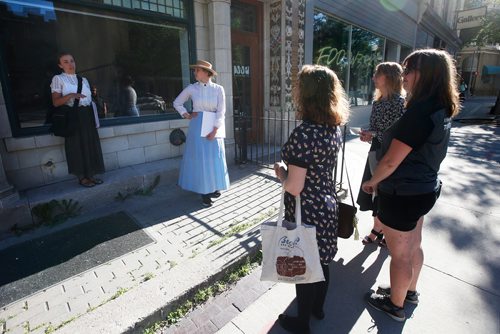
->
<box><xmin>173</xmin><ymin>60</ymin><xmax>229</xmax><ymax>207</ymax></box>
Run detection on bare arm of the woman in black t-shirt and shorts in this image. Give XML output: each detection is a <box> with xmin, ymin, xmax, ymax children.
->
<box><xmin>362</xmin><ymin>139</ymin><xmax>412</xmax><ymax>194</ymax></box>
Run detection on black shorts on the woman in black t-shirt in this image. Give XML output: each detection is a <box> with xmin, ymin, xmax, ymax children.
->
<box><xmin>377</xmin><ymin>189</ymin><xmax>440</xmax><ymax>232</ymax></box>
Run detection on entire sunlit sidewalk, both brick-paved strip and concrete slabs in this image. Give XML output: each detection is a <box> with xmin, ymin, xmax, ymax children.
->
<box><xmin>0</xmin><ymin>99</ymin><xmax>500</xmax><ymax>334</ymax></box>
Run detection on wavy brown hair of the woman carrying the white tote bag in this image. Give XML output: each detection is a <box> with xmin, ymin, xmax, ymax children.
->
<box><xmin>294</xmin><ymin>65</ymin><xmax>349</xmax><ymax>126</ymax></box>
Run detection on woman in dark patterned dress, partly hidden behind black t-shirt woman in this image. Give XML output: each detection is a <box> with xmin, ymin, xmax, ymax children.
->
<box><xmin>357</xmin><ymin>62</ymin><xmax>404</xmax><ymax>247</ymax></box>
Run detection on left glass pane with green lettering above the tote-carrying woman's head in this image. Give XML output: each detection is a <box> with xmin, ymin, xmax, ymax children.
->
<box><xmin>313</xmin><ymin>12</ymin><xmax>349</xmax><ymax>90</ymax></box>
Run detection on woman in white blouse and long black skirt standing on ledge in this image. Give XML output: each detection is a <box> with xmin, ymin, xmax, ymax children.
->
<box><xmin>50</xmin><ymin>53</ymin><xmax>104</xmax><ymax>187</ymax></box>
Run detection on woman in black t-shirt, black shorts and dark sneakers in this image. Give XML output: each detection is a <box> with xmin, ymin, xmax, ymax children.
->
<box><xmin>362</xmin><ymin>49</ymin><xmax>460</xmax><ymax>321</ymax></box>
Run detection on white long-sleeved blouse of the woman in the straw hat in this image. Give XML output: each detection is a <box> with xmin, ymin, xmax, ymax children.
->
<box><xmin>174</xmin><ymin>80</ymin><xmax>226</xmax><ymax>128</ymax></box>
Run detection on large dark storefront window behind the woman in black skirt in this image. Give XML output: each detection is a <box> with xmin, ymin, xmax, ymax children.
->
<box><xmin>0</xmin><ymin>0</ymin><xmax>190</xmax><ymax>133</ymax></box>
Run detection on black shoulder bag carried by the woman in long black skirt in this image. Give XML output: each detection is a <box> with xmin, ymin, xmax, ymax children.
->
<box><xmin>50</xmin><ymin>75</ymin><xmax>83</xmax><ymax>138</ymax></box>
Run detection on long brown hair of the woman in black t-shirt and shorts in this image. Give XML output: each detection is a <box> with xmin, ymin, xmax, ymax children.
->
<box><xmin>403</xmin><ymin>49</ymin><xmax>460</xmax><ymax>117</ymax></box>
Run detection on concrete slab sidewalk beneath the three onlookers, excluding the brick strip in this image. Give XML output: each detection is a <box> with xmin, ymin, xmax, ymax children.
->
<box><xmin>161</xmin><ymin>98</ymin><xmax>500</xmax><ymax>334</ymax></box>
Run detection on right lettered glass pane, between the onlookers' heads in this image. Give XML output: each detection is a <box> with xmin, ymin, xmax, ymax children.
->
<box><xmin>349</xmin><ymin>26</ymin><xmax>385</xmax><ymax>106</ymax></box>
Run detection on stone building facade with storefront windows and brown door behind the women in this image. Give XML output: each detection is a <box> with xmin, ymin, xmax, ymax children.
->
<box><xmin>0</xmin><ymin>0</ymin><xmax>460</xmax><ymax>205</ymax></box>
